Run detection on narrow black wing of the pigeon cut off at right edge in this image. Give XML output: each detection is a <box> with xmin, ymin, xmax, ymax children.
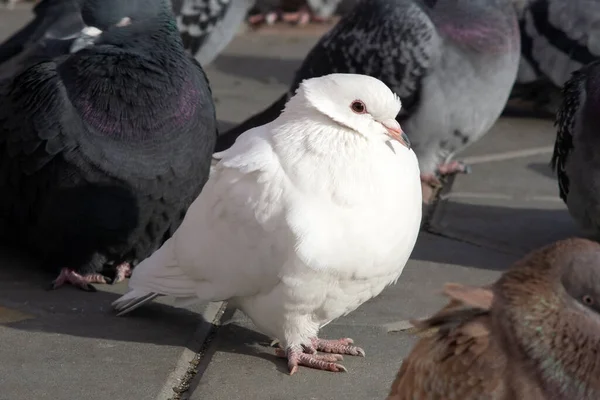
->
<box><xmin>550</xmin><ymin>62</ymin><xmax>600</xmax><ymax>201</ymax></box>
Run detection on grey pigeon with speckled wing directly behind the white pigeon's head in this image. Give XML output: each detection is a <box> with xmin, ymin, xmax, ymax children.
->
<box><xmin>216</xmin><ymin>0</ymin><xmax>520</xmax><ymax>192</ymax></box>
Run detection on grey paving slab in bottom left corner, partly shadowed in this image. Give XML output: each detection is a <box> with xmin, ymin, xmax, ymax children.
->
<box><xmin>0</xmin><ymin>245</ymin><xmax>223</xmax><ymax>400</ymax></box>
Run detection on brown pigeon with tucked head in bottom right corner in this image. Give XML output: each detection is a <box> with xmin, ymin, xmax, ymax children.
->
<box><xmin>387</xmin><ymin>239</ymin><xmax>600</xmax><ymax>400</ymax></box>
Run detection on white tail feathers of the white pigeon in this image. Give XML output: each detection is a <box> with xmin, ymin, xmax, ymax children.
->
<box><xmin>112</xmin><ymin>238</ymin><xmax>197</xmax><ymax>316</ymax></box>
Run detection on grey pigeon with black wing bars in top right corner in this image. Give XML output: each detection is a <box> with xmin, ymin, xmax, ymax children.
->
<box><xmin>511</xmin><ymin>0</ymin><xmax>600</xmax><ymax>113</ymax></box>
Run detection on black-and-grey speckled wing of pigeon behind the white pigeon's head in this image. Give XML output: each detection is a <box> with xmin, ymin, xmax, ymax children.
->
<box><xmin>291</xmin><ymin>0</ymin><xmax>440</xmax><ymax>113</ymax></box>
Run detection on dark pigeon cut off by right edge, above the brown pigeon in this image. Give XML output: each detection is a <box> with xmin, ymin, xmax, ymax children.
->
<box><xmin>551</xmin><ymin>61</ymin><xmax>600</xmax><ymax>237</ymax></box>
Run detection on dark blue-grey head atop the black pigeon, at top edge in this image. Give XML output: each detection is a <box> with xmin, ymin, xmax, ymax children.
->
<box><xmin>81</xmin><ymin>0</ymin><xmax>169</xmax><ymax>31</ymax></box>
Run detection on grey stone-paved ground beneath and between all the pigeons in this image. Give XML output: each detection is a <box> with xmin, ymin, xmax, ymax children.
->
<box><xmin>0</xmin><ymin>6</ymin><xmax>578</xmax><ymax>400</ymax></box>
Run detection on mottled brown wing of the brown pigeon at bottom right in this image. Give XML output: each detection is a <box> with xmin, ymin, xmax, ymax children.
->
<box><xmin>388</xmin><ymin>288</ymin><xmax>507</xmax><ymax>400</ymax></box>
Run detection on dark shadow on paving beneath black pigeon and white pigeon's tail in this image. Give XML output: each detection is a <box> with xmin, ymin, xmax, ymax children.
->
<box><xmin>0</xmin><ymin>249</ymin><xmax>210</xmax><ymax>346</ymax></box>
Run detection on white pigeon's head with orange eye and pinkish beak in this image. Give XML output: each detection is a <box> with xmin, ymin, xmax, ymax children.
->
<box><xmin>286</xmin><ymin>74</ymin><xmax>410</xmax><ymax>149</ymax></box>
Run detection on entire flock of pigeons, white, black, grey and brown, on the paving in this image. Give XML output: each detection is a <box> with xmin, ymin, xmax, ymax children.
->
<box><xmin>0</xmin><ymin>0</ymin><xmax>600</xmax><ymax>400</ymax></box>
